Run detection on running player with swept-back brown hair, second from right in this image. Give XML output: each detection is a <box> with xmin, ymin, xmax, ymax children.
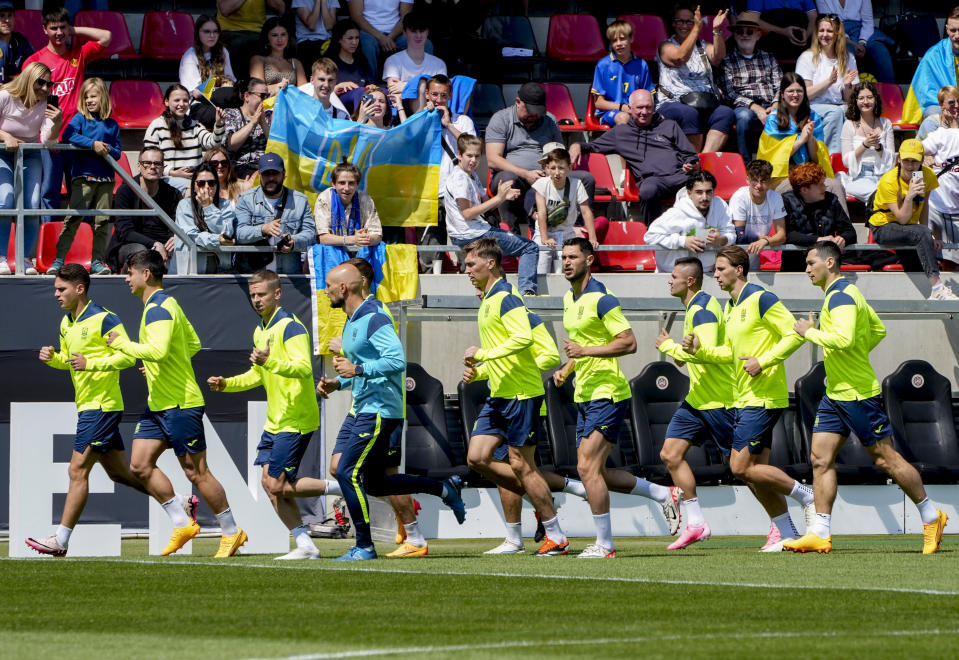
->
<box><xmin>683</xmin><ymin>245</ymin><xmax>815</xmax><ymax>552</ymax></box>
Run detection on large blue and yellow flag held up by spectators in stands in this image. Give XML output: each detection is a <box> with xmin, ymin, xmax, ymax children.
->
<box><xmin>266</xmin><ymin>86</ymin><xmax>443</xmax><ymax>227</ymax></box>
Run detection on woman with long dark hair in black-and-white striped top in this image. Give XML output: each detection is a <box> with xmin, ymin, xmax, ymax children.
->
<box><xmin>143</xmin><ymin>83</ymin><xmax>224</xmax><ymax>192</ymax></box>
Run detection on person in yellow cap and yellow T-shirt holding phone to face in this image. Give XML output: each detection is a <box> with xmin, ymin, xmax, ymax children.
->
<box><xmin>867</xmin><ymin>139</ymin><xmax>959</xmax><ymax>300</ymax></box>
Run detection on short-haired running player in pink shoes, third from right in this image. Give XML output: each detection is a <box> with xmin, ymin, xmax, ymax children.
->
<box><xmin>656</xmin><ymin>257</ymin><xmax>733</xmax><ymax>550</ymax></box>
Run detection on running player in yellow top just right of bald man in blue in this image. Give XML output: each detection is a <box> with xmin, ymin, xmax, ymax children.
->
<box><xmin>463</xmin><ymin>238</ymin><xmax>569</xmax><ymax>557</ymax></box>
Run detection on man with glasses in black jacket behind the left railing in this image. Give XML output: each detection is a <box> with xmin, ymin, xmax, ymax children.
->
<box><xmin>107</xmin><ymin>147</ymin><xmax>183</xmax><ymax>272</ymax></box>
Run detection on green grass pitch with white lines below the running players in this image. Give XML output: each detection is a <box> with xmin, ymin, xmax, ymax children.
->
<box><xmin>0</xmin><ymin>536</ymin><xmax>959</xmax><ymax>660</ymax></box>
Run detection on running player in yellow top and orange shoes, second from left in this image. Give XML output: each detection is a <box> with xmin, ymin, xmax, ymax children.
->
<box><xmin>107</xmin><ymin>250</ymin><xmax>247</xmax><ymax>557</ymax></box>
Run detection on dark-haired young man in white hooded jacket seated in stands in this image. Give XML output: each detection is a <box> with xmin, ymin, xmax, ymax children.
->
<box><xmin>646</xmin><ymin>171</ymin><xmax>736</xmax><ymax>273</ymax></box>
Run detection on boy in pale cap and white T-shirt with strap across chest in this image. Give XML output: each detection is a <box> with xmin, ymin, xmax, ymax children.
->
<box><xmin>530</xmin><ymin>142</ymin><xmax>599</xmax><ymax>275</ymax></box>
